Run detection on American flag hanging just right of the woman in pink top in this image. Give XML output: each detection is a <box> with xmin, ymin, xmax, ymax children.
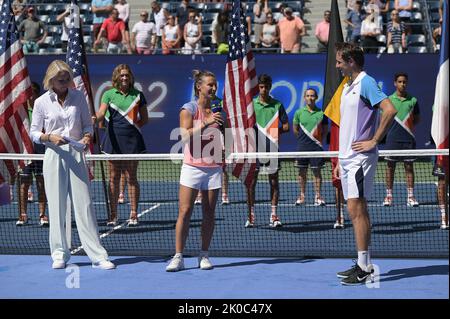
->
<box><xmin>223</xmin><ymin>1</ymin><xmax>258</xmax><ymax>186</ymax></box>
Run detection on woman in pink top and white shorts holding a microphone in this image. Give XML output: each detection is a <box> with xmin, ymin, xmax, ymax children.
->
<box><xmin>166</xmin><ymin>70</ymin><xmax>224</xmax><ymax>272</ymax></box>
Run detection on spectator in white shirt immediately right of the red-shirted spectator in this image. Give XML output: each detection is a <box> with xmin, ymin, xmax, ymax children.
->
<box><xmin>131</xmin><ymin>10</ymin><xmax>156</xmax><ymax>54</ymax></box>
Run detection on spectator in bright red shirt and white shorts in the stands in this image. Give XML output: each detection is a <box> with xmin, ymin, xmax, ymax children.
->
<box><xmin>94</xmin><ymin>9</ymin><xmax>128</xmax><ymax>54</ymax></box>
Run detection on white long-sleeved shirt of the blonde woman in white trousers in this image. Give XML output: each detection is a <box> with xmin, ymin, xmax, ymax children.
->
<box><xmin>30</xmin><ymin>89</ymin><xmax>93</xmax><ymax>144</ymax></box>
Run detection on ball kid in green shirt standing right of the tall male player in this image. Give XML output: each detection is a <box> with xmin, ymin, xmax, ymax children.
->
<box><xmin>383</xmin><ymin>72</ymin><xmax>420</xmax><ymax>207</ymax></box>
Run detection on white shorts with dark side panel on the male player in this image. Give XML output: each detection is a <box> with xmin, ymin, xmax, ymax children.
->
<box><xmin>339</xmin><ymin>154</ymin><xmax>378</xmax><ymax>199</ymax></box>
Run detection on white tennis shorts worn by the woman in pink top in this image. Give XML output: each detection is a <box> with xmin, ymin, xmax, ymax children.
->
<box><xmin>180</xmin><ymin>164</ymin><xmax>223</xmax><ymax>190</ymax></box>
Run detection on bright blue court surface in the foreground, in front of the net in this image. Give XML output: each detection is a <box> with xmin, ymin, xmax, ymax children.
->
<box><xmin>0</xmin><ymin>255</ymin><xmax>449</xmax><ymax>299</ymax></box>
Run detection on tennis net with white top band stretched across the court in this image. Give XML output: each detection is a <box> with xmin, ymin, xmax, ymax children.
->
<box><xmin>0</xmin><ymin>150</ymin><xmax>449</xmax><ymax>258</ymax></box>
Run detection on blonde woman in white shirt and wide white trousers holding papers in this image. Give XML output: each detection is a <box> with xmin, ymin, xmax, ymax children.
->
<box><xmin>30</xmin><ymin>60</ymin><xmax>115</xmax><ymax>269</ymax></box>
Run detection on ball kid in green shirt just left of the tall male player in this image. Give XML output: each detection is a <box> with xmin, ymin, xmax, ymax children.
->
<box><xmin>293</xmin><ymin>88</ymin><xmax>328</xmax><ymax>206</ymax></box>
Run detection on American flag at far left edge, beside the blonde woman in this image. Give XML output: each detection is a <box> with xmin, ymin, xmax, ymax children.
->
<box><xmin>0</xmin><ymin>0</ymin><xmax>33</xmax><ymax>204</ymax></box>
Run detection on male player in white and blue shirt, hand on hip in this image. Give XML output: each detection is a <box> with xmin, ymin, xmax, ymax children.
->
<box><xmin>333</xmin><ymin>43</ymin><xmax>397</xmax><ymax>285</ymax></box>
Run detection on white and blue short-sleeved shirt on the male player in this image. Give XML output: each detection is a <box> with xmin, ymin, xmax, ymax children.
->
<box><xmin>339</xmin><ymin>71</ymin><xmax>387</xmax><ymax>159</ymax></box>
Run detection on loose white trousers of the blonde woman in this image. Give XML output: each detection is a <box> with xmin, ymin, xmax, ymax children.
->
<box><xmin>43</xmin><ymin>144</ymin><xmax>108</xmax><ymax>263</ymax></box>
